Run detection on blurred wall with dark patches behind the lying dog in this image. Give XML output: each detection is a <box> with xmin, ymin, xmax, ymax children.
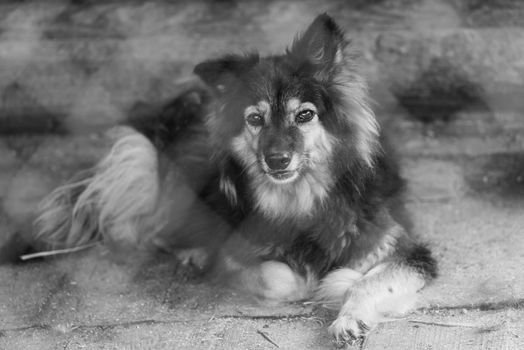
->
<box><xmin>0</xmin><ymin>0</ymin><xmax>524</xmax><ymax>211</ymax></box>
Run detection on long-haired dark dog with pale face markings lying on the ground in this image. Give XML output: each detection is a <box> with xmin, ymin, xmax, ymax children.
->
<box><xmin>29</xmin><ymin>14</ymin><xmax>437</xmax><ymax>344</ymax></box>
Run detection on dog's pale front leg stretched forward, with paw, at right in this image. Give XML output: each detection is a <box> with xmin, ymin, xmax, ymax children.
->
<box><xmin>329</xmin><ymin>261</ymin><xmax>426</xmax><ymax>344</ymax></box>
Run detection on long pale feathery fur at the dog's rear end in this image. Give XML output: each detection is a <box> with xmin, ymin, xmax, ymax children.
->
<box><xmin>34</xmin><ymin>131</ymin><xmax>159</xmax><ymax>247</ymax></box>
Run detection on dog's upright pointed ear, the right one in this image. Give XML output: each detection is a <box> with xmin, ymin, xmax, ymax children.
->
<box><xmin>287</xmin><ymin>14</ymin><xmax>347</xmax><ymax>79</ymax></box>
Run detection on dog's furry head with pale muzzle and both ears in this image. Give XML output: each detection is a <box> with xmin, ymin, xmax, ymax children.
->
<box><xmin>195</xmin><ymin>15</ymin><xmax>378</xmax><ymax>219</ymax></box>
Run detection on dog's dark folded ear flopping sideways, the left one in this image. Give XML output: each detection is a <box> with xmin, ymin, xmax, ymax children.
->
<box><xmin>193</xmin><ymin>54</ymin><xmax>259</xmax><ymax>95</ymax></box>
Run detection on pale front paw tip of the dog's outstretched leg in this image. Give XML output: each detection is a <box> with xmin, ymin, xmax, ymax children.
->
<box><xmin>328</xmin><ymin>316</ymin><xmax>374</xmax><ymax>347</ymax></box>
